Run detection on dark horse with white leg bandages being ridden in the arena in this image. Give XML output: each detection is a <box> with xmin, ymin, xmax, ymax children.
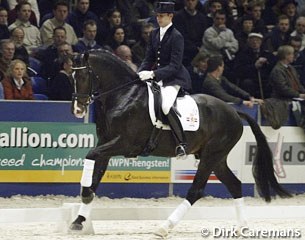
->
<box><xmin>70</xmin><ymin>50</ymin><xmax>291</xmax><ymax>237</ymax></box>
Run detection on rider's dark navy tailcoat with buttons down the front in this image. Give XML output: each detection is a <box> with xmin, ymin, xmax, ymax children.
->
<box><xmin>138</xmin><ymin>26</ymin><xmax>191</xmax><ymax>90</ymax></box>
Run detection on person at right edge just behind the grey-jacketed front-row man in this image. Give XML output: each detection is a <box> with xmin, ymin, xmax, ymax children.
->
<box><xmin>289</xmin><ymin>36</ymin><xmax>305</xmax><ymax>87</ymax></box>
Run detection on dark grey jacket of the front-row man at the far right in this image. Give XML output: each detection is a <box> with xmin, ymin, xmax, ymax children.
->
<box><xmin>270</xmin><ymin>62</ymin><xmax>305</xmax><ymax>99</ymax></box>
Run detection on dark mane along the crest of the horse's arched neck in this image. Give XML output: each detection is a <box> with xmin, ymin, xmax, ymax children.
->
<box><xmin>89</xmin><ymin>49</ymin><xmax>137</xmax><ymax>79</ymax></box>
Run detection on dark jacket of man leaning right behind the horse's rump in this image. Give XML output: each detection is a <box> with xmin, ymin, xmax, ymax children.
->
<box><xmin>202</xmin><ymin>75</ymin><xmax>250</xmax><ymax>104</ymax></box>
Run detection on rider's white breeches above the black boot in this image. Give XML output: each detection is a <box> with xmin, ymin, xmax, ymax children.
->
<box><xmin>161</xmin><ymin>85</ymin><xmax>180</xmax><ymax>115</ymax></box>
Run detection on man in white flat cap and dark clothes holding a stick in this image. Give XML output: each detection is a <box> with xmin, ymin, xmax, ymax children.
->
<box><xmin>234</xmin><ymin>33</ymin><xmax>275</xmax><ymax>98</ymax></box>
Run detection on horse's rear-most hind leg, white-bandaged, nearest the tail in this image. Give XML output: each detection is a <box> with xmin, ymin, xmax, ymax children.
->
<box><xmin>213</xmin><ymin>157</ymin><xmax>247</xmax><ymax>227</ymax></box>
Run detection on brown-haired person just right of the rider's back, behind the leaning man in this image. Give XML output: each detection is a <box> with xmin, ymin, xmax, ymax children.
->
<box><xmin>187</xmin><ymin>52</ymin><xmax>209</xmax><ymax>94</ymax></box>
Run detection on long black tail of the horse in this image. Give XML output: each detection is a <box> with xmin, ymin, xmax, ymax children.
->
<box><xmin>237</xmin><ymin>112</ymin><xmax>291</xmax><ymax>202</ymax></box>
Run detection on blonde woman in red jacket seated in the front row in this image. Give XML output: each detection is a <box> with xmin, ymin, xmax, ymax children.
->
<box><xmin>2</xmin><ymin>59</ymin><xmax>34</xmax><ymax>100</ymax></box>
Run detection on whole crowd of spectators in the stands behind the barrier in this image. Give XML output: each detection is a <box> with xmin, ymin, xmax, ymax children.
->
<box><xmin>0</xmin><ymin>0</ymin><xmax>305</xmax><ymax>113</ymax></box>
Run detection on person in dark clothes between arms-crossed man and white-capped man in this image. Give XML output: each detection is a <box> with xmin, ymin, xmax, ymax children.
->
<box><xmin>235</xmin><ymin>15</ymin><xmax>254</xmax><ymax>51</ymax></box>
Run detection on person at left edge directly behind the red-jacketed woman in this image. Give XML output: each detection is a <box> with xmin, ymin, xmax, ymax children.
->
<box><xmin>0</xmin><ymin>39</ymin><xmax>15</xmax><ymax>81</ymax></box>
